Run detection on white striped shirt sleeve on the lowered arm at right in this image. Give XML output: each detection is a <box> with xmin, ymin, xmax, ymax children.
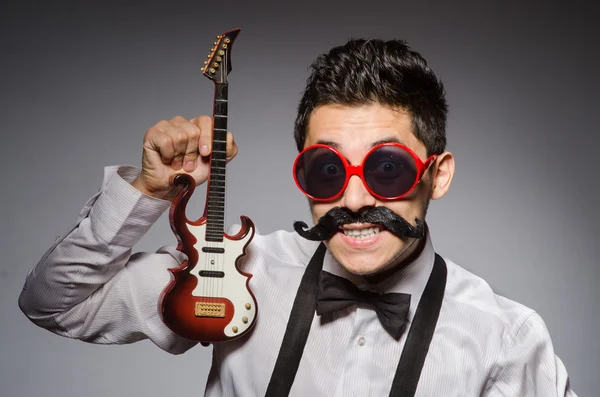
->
<box><xmin>482</xmin><ymin>312</ymin><xmax>577</xmax><ymax>397</ymax></box>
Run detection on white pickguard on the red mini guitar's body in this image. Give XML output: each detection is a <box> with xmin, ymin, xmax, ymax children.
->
<box><xmin>188</xmin><ymin>224</ymin><xmax>256</xmax><ymax>337</ymax></box>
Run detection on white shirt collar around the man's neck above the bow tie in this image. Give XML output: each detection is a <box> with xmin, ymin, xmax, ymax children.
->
<box><xmin>323</xmin><ymin>228</ymin><xmax>435</xmax><ymax>322</ymax></box>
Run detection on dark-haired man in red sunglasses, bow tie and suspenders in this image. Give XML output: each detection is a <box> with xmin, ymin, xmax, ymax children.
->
<box><xmin>19</xmin><ymin>40</ymin><xmax>575</xmax><ymax>397</ymax></box>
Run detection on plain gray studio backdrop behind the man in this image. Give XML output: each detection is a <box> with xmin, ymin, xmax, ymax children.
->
<box><xmin>0</xmin><ymin>0</ymin><xmax>600</xmax><ymax>397</ymax></box>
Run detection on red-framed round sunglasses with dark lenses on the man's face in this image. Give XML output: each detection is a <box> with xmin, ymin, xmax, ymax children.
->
<box><xmin>293</xmin><ymin>142</ymin><xmax>437</xmax><ymax>201</ymax></box>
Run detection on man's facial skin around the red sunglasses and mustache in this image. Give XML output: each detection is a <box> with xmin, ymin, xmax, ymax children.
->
<box><xmin>305</xmin><ymin>104</ymin><xmax>430</xmax><ymax>274</ymax></box>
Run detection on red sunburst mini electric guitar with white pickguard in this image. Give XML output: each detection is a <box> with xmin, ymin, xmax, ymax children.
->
<box><xmin>160</xmin><ymin>29</ymin><xmax>257</xmax><ymax>343</ymax></box>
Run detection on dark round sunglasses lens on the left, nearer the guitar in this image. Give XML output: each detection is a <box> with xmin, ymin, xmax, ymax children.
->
<box><xmin>295</xmin><ymin>147</ymin><xmax>346</xmax><ymax>199</ymax></box>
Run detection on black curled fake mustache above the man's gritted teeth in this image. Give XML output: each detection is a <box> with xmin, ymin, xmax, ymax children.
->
<box><xmin>294</xmin><ymin>207</ymin><xmax>425</xmax><ymax>241</ymax></box>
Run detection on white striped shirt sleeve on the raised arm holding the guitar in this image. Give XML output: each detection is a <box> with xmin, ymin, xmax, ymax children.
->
<box><xmin>19</xmin><ymin>166</ymin><xmax>195</xmax><ymax>354</ymax></box>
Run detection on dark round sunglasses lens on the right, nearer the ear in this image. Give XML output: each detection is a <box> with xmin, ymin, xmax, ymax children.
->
<box><xmin>364</xmin><ymin>145</ymin><xmax>417</xmax><ymax>198</ymax></box>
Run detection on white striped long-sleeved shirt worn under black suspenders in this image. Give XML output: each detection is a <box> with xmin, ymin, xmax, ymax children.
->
<box><xmin>19</xmin><ymin>167</ymin><xmax>575</xmax><ymax>397</ymax></box>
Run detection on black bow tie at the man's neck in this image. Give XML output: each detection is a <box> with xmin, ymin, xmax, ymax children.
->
<box><xmin>317</xmin><ymin>271</ymin><xmax>410</xmax><ymax>339</ymax></box>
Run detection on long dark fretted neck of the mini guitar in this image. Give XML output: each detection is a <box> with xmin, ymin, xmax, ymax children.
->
<box><xmin>206</xmin><ymin>83</ymin><xmax>228</xmax><ymax>242</ymax></box>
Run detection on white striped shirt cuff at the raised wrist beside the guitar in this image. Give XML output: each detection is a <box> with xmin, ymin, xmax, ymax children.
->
<box><xmin>89</xmin><ymin>166</ymin><xmax>171</xmax><ymax>247</ymax></box>
